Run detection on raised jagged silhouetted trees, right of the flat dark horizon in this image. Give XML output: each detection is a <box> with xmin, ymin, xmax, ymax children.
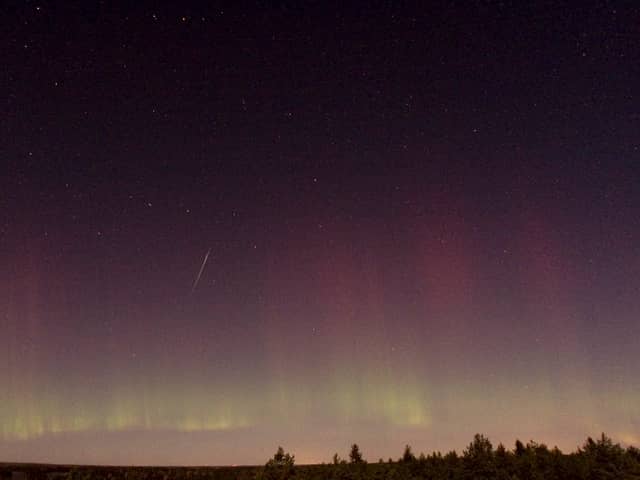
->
<box><xmin>256</xmin><ymin>433</ymin><xmax>640</xmax><ymax>480</ymax></box>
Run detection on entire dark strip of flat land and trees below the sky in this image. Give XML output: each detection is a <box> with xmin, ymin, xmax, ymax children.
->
<box><xmin>0</xmin><ymin>434</ymin><xmax>640</xmax><ymax>480</ymax></box>
